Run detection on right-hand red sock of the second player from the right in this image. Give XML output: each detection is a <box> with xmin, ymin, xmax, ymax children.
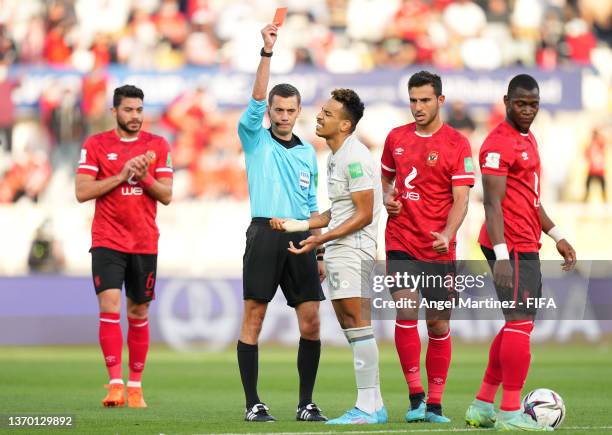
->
<box><xmin>425</xmin><ymin>330</ymin><xmax>452</xmax><ymax>404</ymax></box>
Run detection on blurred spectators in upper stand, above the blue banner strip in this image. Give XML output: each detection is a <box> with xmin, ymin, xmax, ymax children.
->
<box><xmin>0</xmin><ymin>0</ymin><xmax>612</xmax><ymax>72</ymax></box>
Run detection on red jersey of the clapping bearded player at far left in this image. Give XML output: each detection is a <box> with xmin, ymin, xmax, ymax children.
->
<box><xmin>77</xmin><ymin>130</ymin><xmax>173</xmax><ymax>254</ymax></box>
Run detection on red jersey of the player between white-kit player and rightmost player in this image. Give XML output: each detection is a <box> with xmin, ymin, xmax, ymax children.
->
<box><xmin>381</xmin><ymin>123</ymin><xmax>475</xmax><ymax>261</ymax></box>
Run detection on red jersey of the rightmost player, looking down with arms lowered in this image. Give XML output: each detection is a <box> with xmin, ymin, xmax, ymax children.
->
<box><xmin>478</xmin><ymin>121</ymin><xmax>542</xmax><ymax>252</ymax></box>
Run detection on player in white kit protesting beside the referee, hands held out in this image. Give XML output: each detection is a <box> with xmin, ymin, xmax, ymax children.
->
<box><xmin>271</xmin><ymin>89</ymin><xmax>388</xmax><ymax>424</ymax></box>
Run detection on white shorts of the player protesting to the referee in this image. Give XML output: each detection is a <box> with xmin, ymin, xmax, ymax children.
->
<box><xmin>324</xmin><ymin>245</ymin><xmax>376</xmax><ymax>300</ymax></box>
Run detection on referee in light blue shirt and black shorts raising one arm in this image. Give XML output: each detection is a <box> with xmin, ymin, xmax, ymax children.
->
<box><xmin>237</xmin><ymin>24</ymin><xmax>327</xmax><ymax>422</ymax></box>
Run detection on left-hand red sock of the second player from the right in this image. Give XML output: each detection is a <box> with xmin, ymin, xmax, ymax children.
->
<box><xmin>395</xmin><ymin>320</ymin><xmax>423</xmax><ymax>395</ymax></box>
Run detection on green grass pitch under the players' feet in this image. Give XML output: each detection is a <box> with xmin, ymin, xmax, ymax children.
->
<box><xmin>0</xmin><ymin>342</ymin><xmax>612</xmax><ymax>434</ymax></box>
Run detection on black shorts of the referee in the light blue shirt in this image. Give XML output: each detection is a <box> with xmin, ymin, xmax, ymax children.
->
<box><xmin>242</xmin><ymin>218</ymin><xmax>325</xmax><ymax>307</ymax></box>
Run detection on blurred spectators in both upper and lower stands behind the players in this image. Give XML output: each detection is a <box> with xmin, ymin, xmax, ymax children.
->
<box><xmin>0</xmin><ymin>0</ymin><xmax>612</xmax><ymax>203</ymax></box>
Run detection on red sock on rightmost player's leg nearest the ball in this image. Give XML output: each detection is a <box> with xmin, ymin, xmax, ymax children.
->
<box><xmin>499</xmin><ymin>320</ymin><xmax>533</xmax><ymax>411</ymax></box>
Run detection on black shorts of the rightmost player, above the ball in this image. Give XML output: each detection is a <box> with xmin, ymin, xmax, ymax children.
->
<box><xmin>480</xmin><ymin>246</ymin><xmax>542</xmax><ymax>315</ymax></box>
